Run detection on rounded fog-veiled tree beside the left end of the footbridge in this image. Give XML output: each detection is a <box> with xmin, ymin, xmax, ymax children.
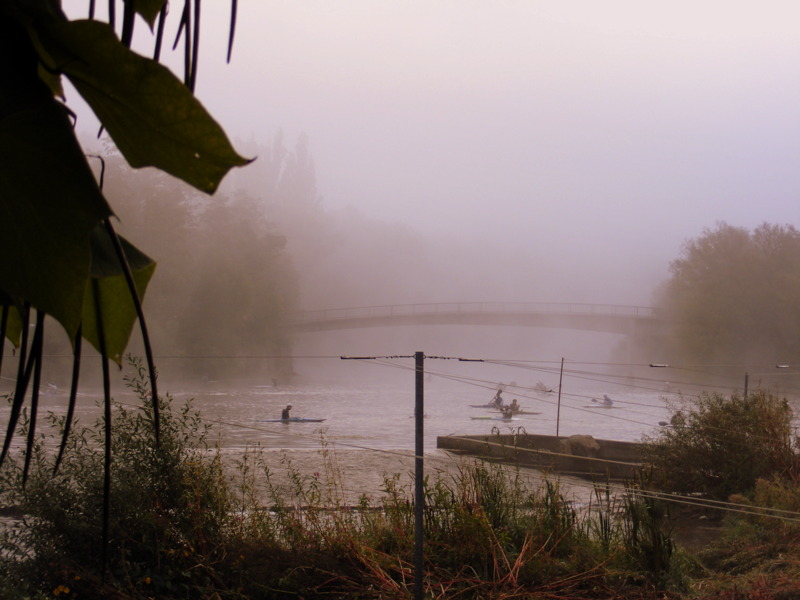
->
<box><xmin>178</xmin><ymin>194</ymin><xmax>297</xmax><ymax>376</ymax></box>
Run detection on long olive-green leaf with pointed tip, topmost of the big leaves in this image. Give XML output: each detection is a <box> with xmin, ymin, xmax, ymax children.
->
<box><xmin>38</xmin><ymin>21</ymin><xmax>250</xmax><ymax>193</ymax></box>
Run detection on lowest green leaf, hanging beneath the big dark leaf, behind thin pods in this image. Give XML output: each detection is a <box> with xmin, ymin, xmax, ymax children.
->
<box><xmin>82</xmin><ymin>226</ymin><xmax>156</xmax><ymax>364</ymax></box>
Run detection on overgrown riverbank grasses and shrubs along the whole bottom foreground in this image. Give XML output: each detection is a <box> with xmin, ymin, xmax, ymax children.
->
<box><xmin>0</xmin><ymin>371</ymin><xmax>800</xmax><ymax>600</ymax></box>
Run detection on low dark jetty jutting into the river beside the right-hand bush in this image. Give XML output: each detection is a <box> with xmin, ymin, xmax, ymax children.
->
<box><xmin>436</xmin><ymin>433</ymin><xmax>643</xmax><ymax>480</ymax></box>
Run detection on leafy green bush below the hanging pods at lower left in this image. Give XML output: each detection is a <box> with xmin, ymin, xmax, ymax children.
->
<box><xmin>0</xmin><ymin>360</ymin><xmax>229</xmax><ymax>598</ymax></box>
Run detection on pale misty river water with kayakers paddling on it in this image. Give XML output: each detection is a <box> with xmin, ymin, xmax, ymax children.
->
<box><xmin>7</xmin><ymin>369</ymin><xmax>800</xmax><ymax>501</ymax></box>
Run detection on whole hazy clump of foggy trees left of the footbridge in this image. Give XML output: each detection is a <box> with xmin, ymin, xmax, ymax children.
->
<box><xmin>107</xmin><ymin>156</ymin><xmax>297</xmax><ymax>376</ymax></box>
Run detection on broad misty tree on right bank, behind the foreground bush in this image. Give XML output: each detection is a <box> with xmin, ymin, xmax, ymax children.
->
<box><xmin>660</xmin><ymin>223</ymin><xmax>800</xmax><ymax>365</ymax></box>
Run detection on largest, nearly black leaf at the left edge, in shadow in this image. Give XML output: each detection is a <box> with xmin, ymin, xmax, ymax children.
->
<box><xmin>0</xmin><ymin>99</ymin><xmax>111</xmax><ymax>339</ymax></box>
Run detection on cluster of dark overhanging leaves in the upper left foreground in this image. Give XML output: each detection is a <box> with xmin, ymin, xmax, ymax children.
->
<box><xmin>0</xmin><ymin>0</ymin><xmax>249</xmax><ymax>354</ymax></box>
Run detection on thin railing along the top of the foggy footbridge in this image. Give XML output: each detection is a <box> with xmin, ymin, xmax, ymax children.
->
<box><xmin>294</xmin><ymin>302</ymin><xmax>656</xmax><ymax>324</ymax></box>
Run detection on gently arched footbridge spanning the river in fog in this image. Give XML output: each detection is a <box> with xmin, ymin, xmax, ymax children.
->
<box><xmin>285</xmin><ymin>302</ymin><xmax>664</xmax><ymax>335</ymax></box>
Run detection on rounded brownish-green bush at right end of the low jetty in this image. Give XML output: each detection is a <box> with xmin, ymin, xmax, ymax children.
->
<box><xmin>644</xmin><ymin>390</ymin><xmax>798</xmax><ymax>500</ymax></box>
